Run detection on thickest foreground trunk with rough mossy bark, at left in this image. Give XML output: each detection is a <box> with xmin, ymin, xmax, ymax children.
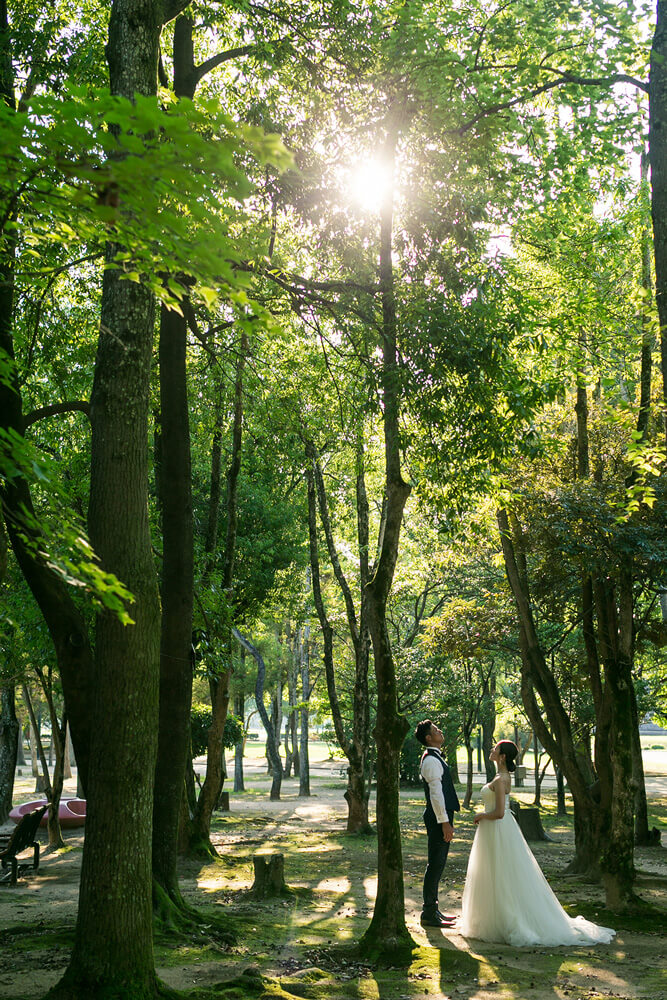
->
<box><xmin>54</xmin><ymin>0</ymin><xmax>162</xmax><ymax>1000</ymax></box>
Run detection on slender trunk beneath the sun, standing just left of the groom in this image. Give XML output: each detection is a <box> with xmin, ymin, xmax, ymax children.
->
<box><xmin>359</xmin><ymin>125</ymin><xmax>413</xmax><ymax>962</ymax></box>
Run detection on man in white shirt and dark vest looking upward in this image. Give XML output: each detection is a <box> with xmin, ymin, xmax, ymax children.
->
<box><xmin>415</xmin><ymin>719</ymin><xmax>461</xmax><ymax>927</ymax></box>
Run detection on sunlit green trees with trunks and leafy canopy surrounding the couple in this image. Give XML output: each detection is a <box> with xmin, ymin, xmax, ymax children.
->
<box><xmin>0</xmin><ymin>0</ymin><xmax>667</xmax><ymax>997</ymax></box>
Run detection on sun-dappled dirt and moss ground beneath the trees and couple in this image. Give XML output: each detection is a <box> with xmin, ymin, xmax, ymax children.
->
<box><xmin>0</xmin><ymin>775</ymin><xmax>667</xmax><ymax>1000</ymax></box>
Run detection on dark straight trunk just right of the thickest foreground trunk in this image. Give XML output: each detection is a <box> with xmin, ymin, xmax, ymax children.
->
<box><xmin>153</xmin><ymin>294</ymin><xmax>194</xmax><ymax>908</ymax></box>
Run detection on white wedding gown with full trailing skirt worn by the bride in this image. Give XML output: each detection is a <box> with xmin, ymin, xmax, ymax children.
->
<box><xmin>459</xmin><ymin>785</ymin><xmax>616</xmax><ymax>946</ymax></box>
